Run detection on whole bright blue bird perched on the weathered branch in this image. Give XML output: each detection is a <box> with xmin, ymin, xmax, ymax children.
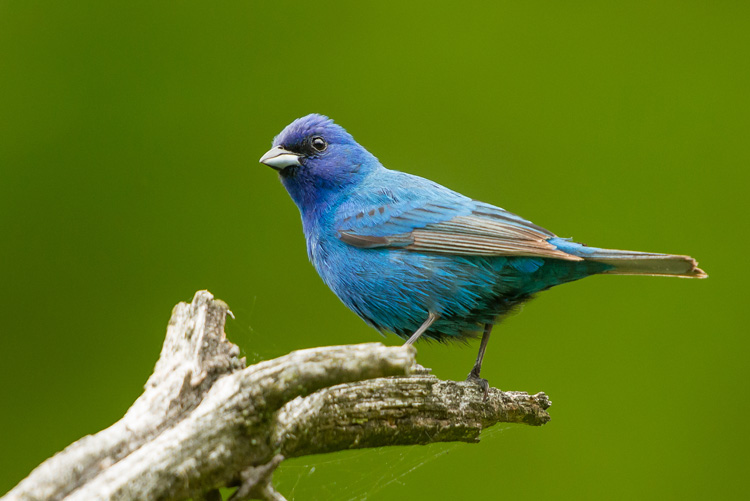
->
<box><xmin>260</xmin><ymin>114</ymin><xmax>707</xmax><ymax>398</ymax></box>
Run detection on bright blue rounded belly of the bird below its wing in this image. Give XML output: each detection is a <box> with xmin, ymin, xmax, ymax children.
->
<box><xmin>310</xmin><ymin>237</ymin><xmax>547</xmax><ymax>339</ymax></box>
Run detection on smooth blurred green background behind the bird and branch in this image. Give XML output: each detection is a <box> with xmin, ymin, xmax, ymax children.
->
<box><xmin>0</xmin><ymin>0</ymin><xmax>750</xmax><ymax>499</ymax></box>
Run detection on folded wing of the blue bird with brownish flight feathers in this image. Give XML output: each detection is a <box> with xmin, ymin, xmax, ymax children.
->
<box><xmin>336</xmin><ymin>199</ymin><xmax>582</xmax><ymax>261</ymax></box>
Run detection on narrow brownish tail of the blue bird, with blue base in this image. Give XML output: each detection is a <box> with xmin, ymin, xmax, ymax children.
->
<box><xmin>549</xmin><ymin>238</ymin><xmax>708</xmax><ymax>278</ymax></box>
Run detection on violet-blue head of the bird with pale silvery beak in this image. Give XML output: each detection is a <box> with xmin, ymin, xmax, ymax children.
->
<box><xmin>260</xmin><ymin>113</ymin><xmax>380</xmax><ymax>212</ymax></box>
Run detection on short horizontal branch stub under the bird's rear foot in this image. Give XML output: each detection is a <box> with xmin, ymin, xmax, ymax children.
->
<box><xmin>273</xmin><ymin>375</ymin><xmax>550</xmax><ymax>458</ymax></box>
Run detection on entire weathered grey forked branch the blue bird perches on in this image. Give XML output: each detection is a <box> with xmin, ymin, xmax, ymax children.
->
<box><xmin>2</xmin><ymin>291</ymin><xmax>550</xmax><ymax>500</ymax></box>
